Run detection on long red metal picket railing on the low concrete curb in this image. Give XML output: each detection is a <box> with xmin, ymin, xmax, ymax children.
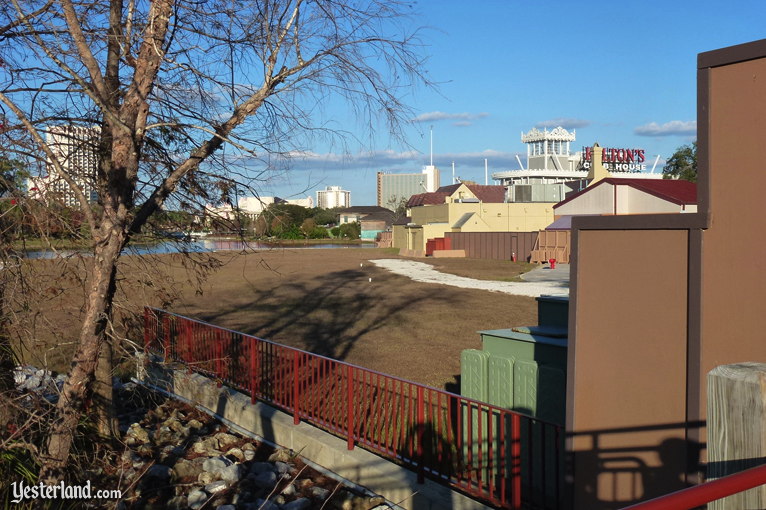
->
<box><xmin>144</xmin><ymin>308</ymin><xmax>564</xmax><ymax>509</ymax></box>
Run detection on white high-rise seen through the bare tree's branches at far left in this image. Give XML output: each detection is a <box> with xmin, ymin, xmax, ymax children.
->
<box><xmin>29</xmin><ymin>126</ymin><xmax>101</xmax><ymax>207</ymax></box>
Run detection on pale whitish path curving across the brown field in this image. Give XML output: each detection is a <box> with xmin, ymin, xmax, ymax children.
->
<box><xmin>370</xmin><ymin>259</ymin><xmax>569</xmax><ymax>297</ymax></box>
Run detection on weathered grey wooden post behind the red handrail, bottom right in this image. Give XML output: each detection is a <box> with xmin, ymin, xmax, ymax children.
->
<box><xmin>707</xmin><ymin>363</ymin><xmax>766</xmax><ymax>510</ymax></box>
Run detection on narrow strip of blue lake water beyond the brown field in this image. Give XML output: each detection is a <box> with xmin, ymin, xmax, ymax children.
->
<box><xmin>26</xmin><ymin>239</ymin><xmax>375</xmax><ymax>259</ymax></box>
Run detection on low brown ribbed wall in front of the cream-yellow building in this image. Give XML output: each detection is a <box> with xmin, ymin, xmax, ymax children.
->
<box><xmin>444</xmin><ymin>232</ymin><xmax>538</xmax><ymax>261</ymax></box>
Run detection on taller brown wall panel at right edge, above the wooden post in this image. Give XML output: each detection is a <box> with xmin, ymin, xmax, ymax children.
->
<box><xmin>699</xmin><ymin>51</ymin><xmax>766</xmax><ymax>438</ymax></box>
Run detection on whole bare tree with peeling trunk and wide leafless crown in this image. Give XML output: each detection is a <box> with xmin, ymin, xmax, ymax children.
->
<box><xmin>0</xmin><ymin>0</ymin><xmax>427</xmax><ymax>481</ymax></box>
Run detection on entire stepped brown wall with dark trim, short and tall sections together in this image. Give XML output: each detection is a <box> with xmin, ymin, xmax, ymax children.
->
<box><xmin>567</xmin><ymin>40</ymin><xmax>766</xmax><ymax>509</ymax></box>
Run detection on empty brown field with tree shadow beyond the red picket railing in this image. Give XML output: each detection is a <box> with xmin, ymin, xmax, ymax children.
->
<box><xmin>13</xmin><ymin>248</ymin><xmax>537</xmax><ymax>388</ymax></box>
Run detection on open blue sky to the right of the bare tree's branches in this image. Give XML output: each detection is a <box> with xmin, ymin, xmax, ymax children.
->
<box><xmin>260</xmin><ymin>0</ymin><xmax>766</xmax><ymax>205</ymax></box>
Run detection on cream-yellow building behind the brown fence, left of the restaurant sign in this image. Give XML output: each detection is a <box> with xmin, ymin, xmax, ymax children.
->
<box><xmin>393</xmin><ymin>183</ymin><xmax>554</xmax><ymax>253</ymax></box>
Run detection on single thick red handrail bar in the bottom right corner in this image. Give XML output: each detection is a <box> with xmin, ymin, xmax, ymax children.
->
<box><xmin>623</xmin><ymin>465</ymin><xmax>766</xmax><ymax>510</ymax></box>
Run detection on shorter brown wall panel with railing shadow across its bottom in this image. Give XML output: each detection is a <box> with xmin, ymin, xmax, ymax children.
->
<box><xmin>567</xmin><ymin>230</ymin><xmax>688</xmax><ymax>508</ymax></box>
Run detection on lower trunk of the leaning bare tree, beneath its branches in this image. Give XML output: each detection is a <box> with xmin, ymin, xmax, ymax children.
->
<box><xmin>39</xmin><ymin>233</ymin><xmax>125</xmax><ymax>484</ymax></box>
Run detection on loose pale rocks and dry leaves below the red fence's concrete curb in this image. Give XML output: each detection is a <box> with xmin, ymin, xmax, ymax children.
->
<box><xmin>14</xmin><ymin>367</ymin><xmax>389</xmax><ymax>510</ymax></box>
